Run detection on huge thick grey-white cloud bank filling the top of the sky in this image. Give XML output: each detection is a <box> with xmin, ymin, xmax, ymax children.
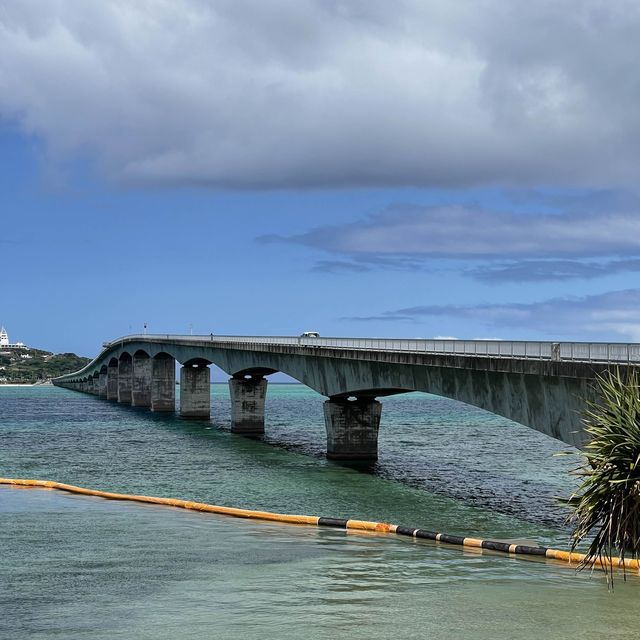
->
<box><xmin>0</xmin><ymin>0</ymin><xmax>640</xmax><ymax>188</ymax></box>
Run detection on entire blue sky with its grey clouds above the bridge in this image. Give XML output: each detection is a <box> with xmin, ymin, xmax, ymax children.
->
<box><xmin>0</xmin><ymin>0</ymin><xmax>640</xmax><ymax>356</ymax></box>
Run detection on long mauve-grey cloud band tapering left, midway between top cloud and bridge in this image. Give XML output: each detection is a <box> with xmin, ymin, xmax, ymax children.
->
<box><xmin>278</xmin><ymin>206</ymin><xmax>640</xmax><ymax>260</ymax></box>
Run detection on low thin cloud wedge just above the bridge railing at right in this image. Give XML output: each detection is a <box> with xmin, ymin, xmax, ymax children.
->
<box><xmin>345</xmin><ymin>289</ymin><xmax>640</xmax><ymax>342</ymax></box>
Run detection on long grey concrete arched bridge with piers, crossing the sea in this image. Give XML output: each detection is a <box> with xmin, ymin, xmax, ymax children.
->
<box><xmin>53</xmin><ymin>334</ymin><xmax>640</xmax><ymax>460</ymax></box>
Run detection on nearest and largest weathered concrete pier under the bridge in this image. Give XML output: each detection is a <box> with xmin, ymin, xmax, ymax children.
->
<box><xmin>324</xmin><ymin>398</ymin><xmax>382</xmax><ymax>461</ymax></box>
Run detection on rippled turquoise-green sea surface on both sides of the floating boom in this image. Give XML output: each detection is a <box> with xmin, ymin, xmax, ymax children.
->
<box><xmin>0</xmin><ymin>384</ymin><xmax>640</xmax><ymax>640</ymax></box>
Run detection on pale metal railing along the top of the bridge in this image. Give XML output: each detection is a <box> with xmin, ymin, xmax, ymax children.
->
<box><xmin>105</xmin><ymin>334</ymin><xmax>640</xmax><ymax>363</ymax></box>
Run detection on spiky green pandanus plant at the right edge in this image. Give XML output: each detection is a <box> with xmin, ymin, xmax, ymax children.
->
<box><xmin>566</xmin><ymin>368</ymin><xmax>640</xmax><ymax>585</ymax></box>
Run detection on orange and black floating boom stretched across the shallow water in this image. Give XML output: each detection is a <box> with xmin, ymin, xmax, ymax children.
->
<box><xmin>0</xmin><ymin>478</ymin><xmax>640</xmax><ymax>570</ymax></box>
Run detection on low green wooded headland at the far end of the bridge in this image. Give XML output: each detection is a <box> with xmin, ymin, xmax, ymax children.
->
<box><xmin>0</xmin><ymin>348</ymin><xmax>90</xmax><ymax>384</ymax></box>
